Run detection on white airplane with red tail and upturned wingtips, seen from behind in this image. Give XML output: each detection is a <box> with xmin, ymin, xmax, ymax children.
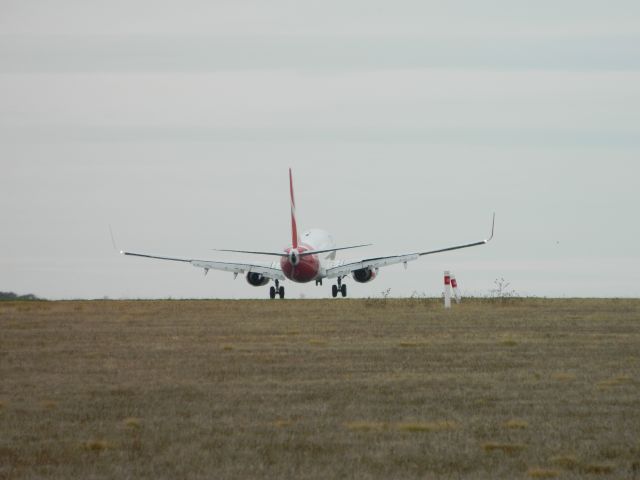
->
<box><xmin>111</xmin><ymin>169</ymin><xmax>495</xmax><ymax>299</ymax></box>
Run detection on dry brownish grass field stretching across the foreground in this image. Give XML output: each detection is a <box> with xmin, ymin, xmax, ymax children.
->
<box><xmin>0</xmin><ymin>299</ymin><xmax>640</xmax><ymax>479</ymax></box>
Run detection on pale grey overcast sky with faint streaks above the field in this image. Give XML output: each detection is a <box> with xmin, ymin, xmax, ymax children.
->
<box><xmin>0</xmin><ymin>0</ymin><xmax>640</xmax><ymax>299</ymax></box>
